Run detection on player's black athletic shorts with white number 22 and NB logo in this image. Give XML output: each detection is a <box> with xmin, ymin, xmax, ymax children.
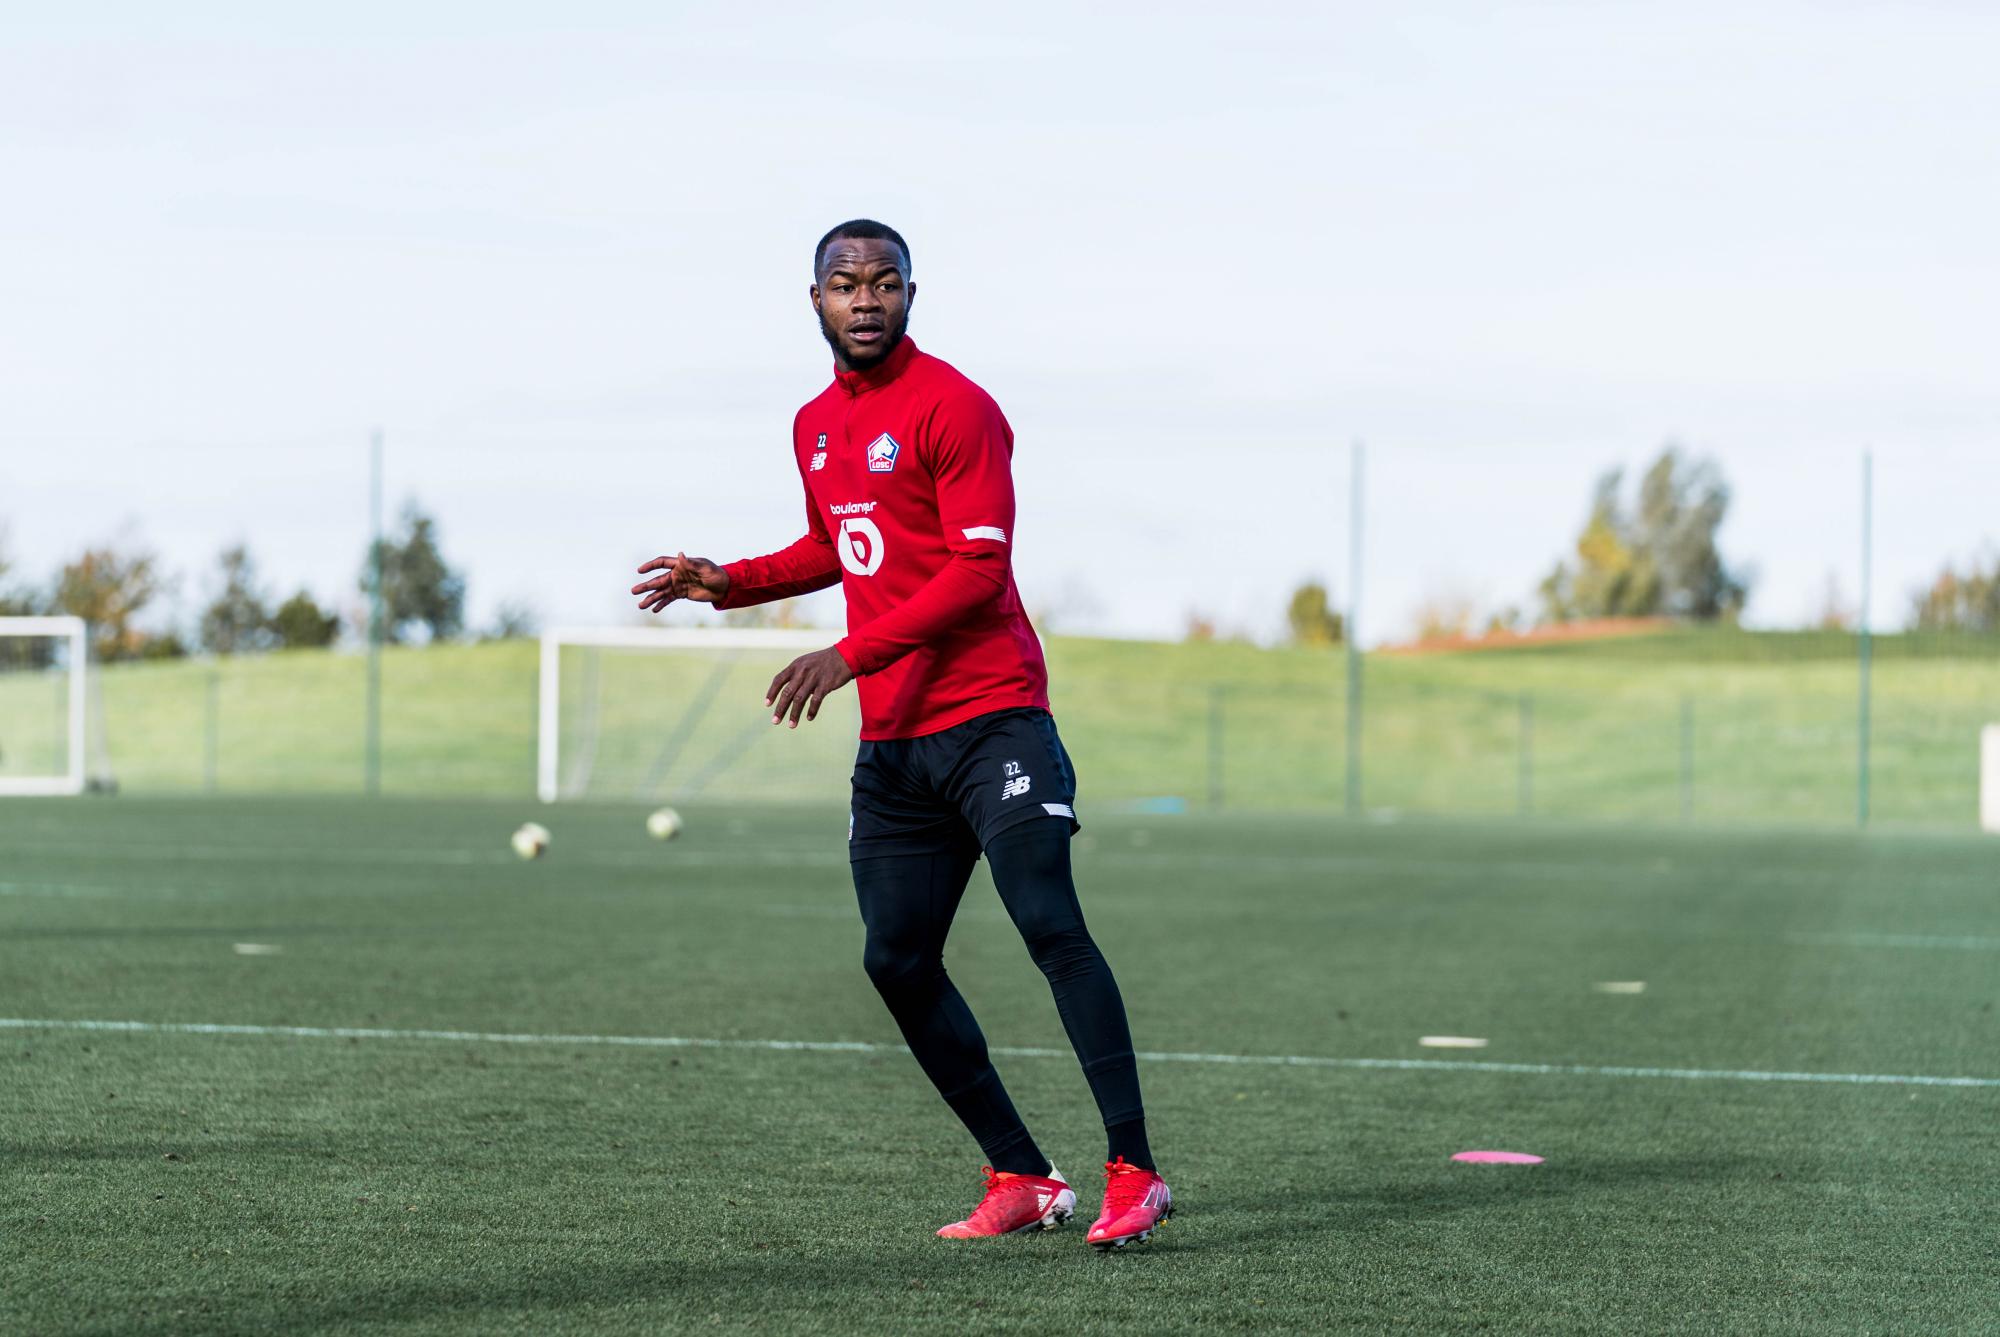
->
<box><xmin>848</xmin><ymin>709</ymin><xmax>1080</xmax><ymax>859</ymax></box>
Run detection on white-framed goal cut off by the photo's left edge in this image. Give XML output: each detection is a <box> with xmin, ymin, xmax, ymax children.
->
<box><xmin>0</xmin><ymin>616</ymin><xmax>90</xmax><ymax>795</ymax></box>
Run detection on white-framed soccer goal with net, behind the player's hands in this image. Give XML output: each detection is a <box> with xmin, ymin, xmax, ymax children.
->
<box><xmin>536</xmin><ymin>628</ymin><xmax>860</xmax><ymax>803</ymax></box>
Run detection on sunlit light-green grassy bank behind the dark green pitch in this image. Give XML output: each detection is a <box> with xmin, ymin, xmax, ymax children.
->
<box><xmin>0</xmin><ymin>626</ymin><xmax>2000</xmax><ymax>829</ymax></box>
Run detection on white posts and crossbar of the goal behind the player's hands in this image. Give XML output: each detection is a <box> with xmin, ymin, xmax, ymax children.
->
<box><xmin>534</xmin><ymin>626</ymin><xmax>832</xmax><ymax>803</ymax></box>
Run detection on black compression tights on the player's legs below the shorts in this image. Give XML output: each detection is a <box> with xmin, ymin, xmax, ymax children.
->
<box><xmin>854</xmin><ymin>821</ymin><xmax>1152</xmax><ymax>1175</ymax></box>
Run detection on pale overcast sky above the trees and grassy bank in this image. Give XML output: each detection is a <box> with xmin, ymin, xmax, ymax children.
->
<box><xmin>0</xmin><ymin>0</ymin><xmax>2000</xmax><ymax>638</ymax></box>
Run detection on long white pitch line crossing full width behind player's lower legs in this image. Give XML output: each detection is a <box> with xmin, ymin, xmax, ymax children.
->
<box><xmin>0</xmin><ymin>1017</ymin><xmax>2000</xmax><ymax>1089</ymax></box>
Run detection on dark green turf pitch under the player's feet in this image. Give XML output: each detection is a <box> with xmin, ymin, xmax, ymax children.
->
<box><xmin>0</xmin><ymin>795</ymin><xmax>2000</xmax><ymax>1333</ymax></box>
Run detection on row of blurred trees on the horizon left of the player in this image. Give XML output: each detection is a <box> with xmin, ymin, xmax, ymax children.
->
<box><xmin>0</xmin><ymin>500</ymin><xmax>534</xmax><ymax>662</ymax></box>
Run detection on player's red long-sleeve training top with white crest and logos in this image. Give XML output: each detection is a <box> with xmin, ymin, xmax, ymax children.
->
<box><xmin>716</xmin><ymin>338</ymin><xmax>1048</xmax><ymax>739</ymax></box>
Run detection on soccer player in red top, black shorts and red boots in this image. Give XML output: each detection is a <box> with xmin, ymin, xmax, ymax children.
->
<box><xmin>632</xmin><ymin>218</ymin><xmax>1174</xmax><ymax>1249</ymax></box>
